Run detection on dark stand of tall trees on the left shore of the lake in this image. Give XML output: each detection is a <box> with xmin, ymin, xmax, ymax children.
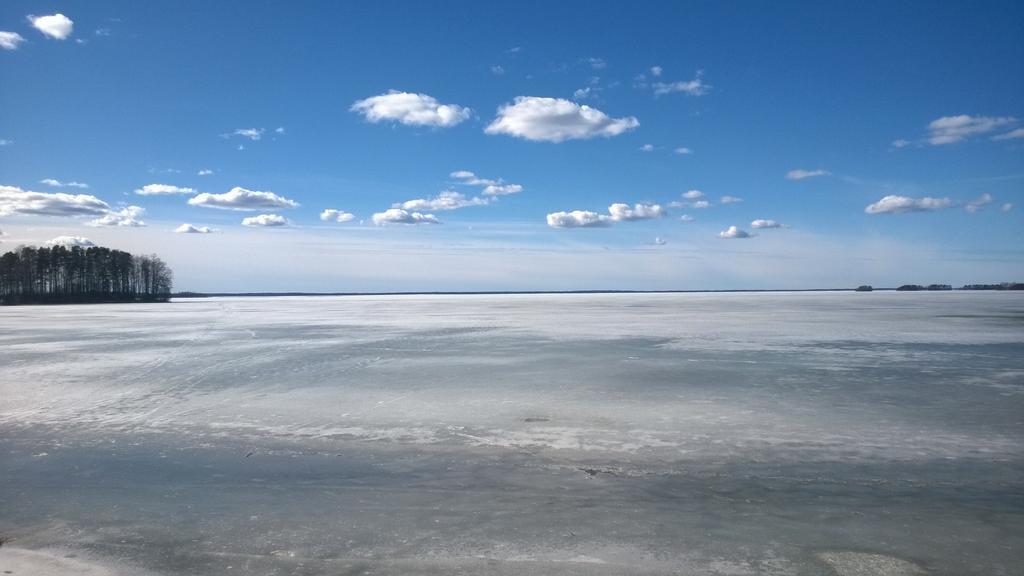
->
<box><xmin>0</xmin><ymin>245</ymin><xmax>173</xmax><ymax>304</ymax></box>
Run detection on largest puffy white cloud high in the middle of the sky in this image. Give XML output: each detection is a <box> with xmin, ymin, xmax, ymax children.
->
<box><xmin>484</xmin><ymin>96</ymin><xmax>640</xmax><ymax>142</ymax></box>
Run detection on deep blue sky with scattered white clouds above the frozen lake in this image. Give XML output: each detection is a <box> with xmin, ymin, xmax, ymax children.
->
<box><xmin>0</xmin><ymin>1</ymin><xmax>1024</xmax><ymax>291</ymax></box>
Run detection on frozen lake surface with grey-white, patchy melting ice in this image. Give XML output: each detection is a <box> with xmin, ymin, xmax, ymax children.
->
<box><xmin>0</xmin><ymin>292</ymin><xmax>1024</xmax><ymax>576</ymax></box>
